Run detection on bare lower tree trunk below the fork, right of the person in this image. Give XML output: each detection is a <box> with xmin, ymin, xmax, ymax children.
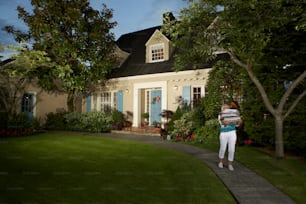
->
<box><xmin>275</xmin><ymin>116</ymin><xmax>284</xmax><ymax>159</ymax></box>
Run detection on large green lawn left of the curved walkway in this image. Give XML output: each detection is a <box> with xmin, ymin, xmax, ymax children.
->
<box><xmin>0</xmin><ymin>133</ymin><xmax>235</xmax><ymax>204</ymax></box>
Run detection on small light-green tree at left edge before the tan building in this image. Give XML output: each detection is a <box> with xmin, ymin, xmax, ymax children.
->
<box><xmin>0</xmin><ymin>46</ymin><xmax>54</xmax><ymax>119</ymax></box>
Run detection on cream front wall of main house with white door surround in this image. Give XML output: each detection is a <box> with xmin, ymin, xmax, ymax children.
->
<box><xmin>82</xmin><ymin>69</ymin><xmax>210</xmax><ymax>126</ymax></box>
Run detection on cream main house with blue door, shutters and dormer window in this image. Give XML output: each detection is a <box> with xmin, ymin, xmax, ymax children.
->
<box><xmin>82</xmin><ymin>13</ymin><xmax>227</xmax><ymax>127</ymax></box>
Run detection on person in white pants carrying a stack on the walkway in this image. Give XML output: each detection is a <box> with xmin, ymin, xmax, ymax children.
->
<box><xmin>218</xmin><ymin>104</ymin><xmax>241</xmax><ymax>171</ymax></box>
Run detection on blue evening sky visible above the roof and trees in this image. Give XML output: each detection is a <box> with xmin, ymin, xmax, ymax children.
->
<box><xmin>0</xmin><ymin>0</ymin><xmax>187</xmax><ymax>58</ymax></box>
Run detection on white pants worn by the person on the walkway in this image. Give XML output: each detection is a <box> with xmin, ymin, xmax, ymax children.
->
<box><xmin>219</xmin><ymin>130</ymin><xmax>237</xmax><ymax>161</ymax></box>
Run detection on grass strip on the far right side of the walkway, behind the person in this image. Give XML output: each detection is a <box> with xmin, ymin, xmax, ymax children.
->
<box><xmin>196</xmin><ymin>137</ymin><xmax>306</xmax><ymax>203</ymax></box>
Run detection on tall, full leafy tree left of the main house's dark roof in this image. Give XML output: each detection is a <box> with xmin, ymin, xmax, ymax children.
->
<box><xmin>6</xmin><ymin>0</ymin><xmax>116</xmax><ymax>111</ymax></box>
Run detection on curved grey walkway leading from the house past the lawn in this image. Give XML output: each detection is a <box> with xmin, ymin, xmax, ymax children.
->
<box><xmin>102</xmin><ymin>133</ymin><xmax>295</xmax><ymax>204</ymax></box>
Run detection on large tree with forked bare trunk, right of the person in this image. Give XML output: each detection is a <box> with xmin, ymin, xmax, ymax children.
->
<box><xmin>166</xmin><ymin>0</ymin><xmax>306</xmax><ymax>158</ymax></box>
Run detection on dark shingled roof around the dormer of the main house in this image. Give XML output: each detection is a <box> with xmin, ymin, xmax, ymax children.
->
<box><xmin>110</xmin><ymin>26</ymin><xmax>228</xmax><ymax>78</ymax></box>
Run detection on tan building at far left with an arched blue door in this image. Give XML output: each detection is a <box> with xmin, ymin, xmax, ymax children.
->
<box><xmin>0</xmin><ymin>59</ymin><xmax>67</xmax><ymax>122</ymax></box>
